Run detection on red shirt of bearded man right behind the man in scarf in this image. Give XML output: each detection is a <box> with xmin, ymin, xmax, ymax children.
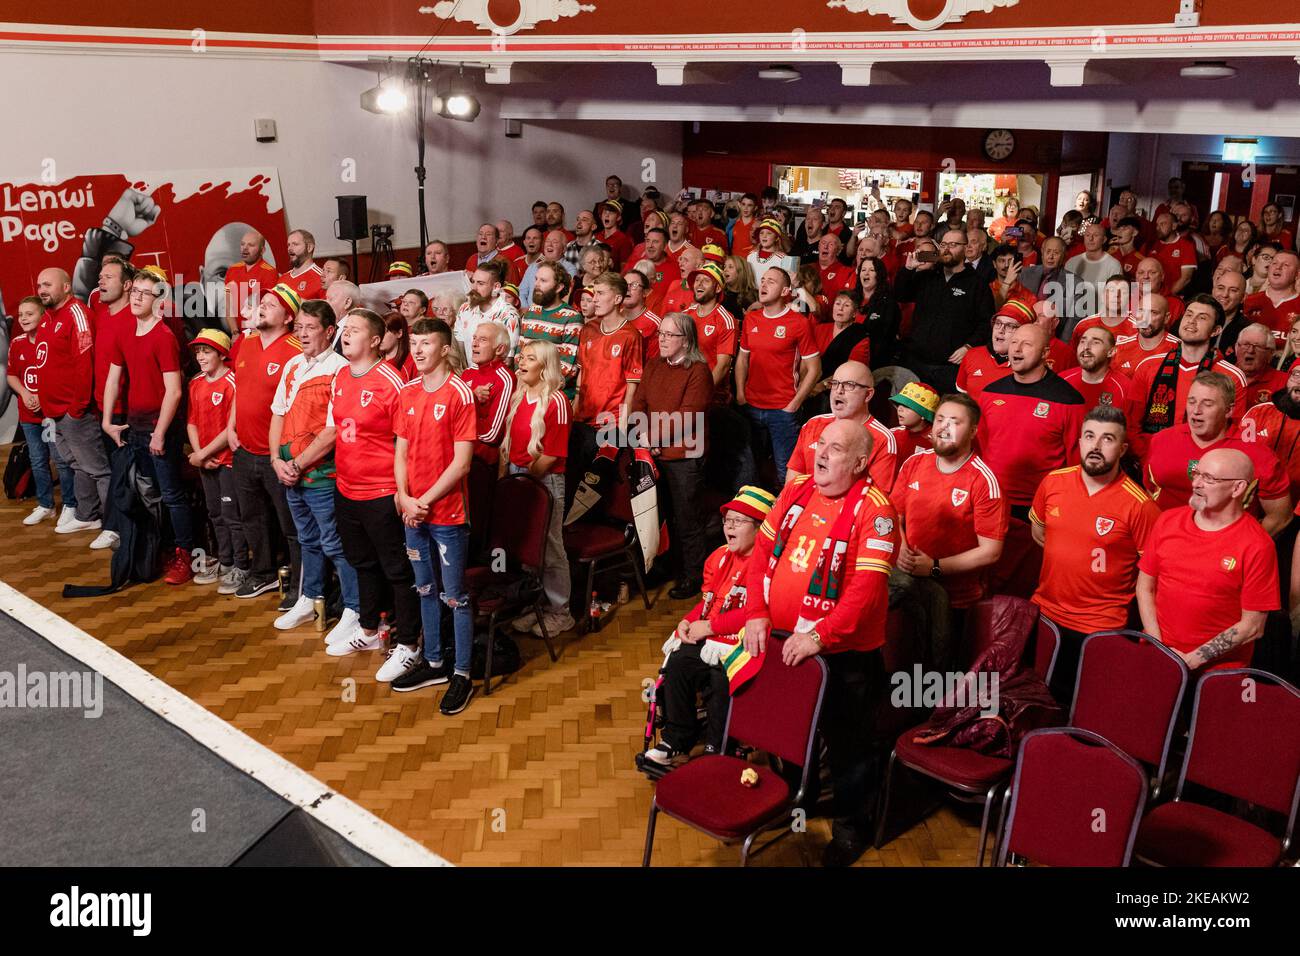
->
<box><xmin>891</xmin><ymin>451</ymin><xmax>1010</xmax><ymax>607</ymax></box>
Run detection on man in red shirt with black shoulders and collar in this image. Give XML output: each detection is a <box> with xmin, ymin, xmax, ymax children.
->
<box><xmin>979</xmin><ymin>325</ymin><xmax>1087</xmax><ymax>519</ymax></box>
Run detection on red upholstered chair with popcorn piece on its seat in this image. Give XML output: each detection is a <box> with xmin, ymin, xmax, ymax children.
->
<box><xmin>641</xmin><ymin>632</ymin><xmax>827</xmax><ymax>866</ymax></box>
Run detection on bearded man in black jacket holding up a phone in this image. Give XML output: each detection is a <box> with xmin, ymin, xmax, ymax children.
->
<box><xmin>896</xmin><ymin>229</ymin><xmax>993</xmax><ymax>393</ymax></box>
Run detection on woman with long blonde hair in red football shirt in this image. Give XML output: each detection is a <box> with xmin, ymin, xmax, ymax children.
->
<box><xmin>501</xmin><ymin>339</ymin><xmax>573</xmax><ymax>637</ymax></box>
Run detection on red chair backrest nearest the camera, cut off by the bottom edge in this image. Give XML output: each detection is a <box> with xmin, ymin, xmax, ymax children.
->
<box><xmin>997</xmin><ymin>727</ymin><xmax>1147</xmax><ymax>866</ymax></box>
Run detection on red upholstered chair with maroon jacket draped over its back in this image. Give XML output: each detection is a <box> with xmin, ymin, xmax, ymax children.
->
<box><xmin>875</xmin><ymin>597</ymin><xmax>1061</xmax><ymax>866</ymax></box>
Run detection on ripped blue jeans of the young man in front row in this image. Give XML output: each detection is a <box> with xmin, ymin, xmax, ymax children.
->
<box><xmin>403</xmin><ymin>524</ymin><xmax>475</xmax><ymax>676</ymax></box>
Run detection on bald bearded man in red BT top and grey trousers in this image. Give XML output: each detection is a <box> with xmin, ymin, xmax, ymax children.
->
<box><xmin>27</xmin><ymin>269</ymin><xmax>117</xmax><ymax>550</ymax></box>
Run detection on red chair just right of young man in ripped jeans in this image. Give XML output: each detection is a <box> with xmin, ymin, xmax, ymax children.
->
<box><xmin>465</xmin><ymin>475</ymin><xmax>559</xmax><ymax>695</ymax></box>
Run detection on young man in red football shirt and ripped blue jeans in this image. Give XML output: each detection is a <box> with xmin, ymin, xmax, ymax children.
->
<box><xmin>389</xmin><ymin>319</ymin><xmax>491</xmax><ymax>714</ymax></box>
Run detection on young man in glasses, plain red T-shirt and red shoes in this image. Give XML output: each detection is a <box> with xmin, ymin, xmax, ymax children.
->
<box><xmin>101</xmin><ymin>265</ymin><xmax>194</xmax><ymax>584</ymax></box>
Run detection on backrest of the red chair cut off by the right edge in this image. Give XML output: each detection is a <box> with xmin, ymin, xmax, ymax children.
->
<box><xmin>1178</xmin><ymin>667</ymin><xmax>1300</xmax><ymax>834</ymax></box>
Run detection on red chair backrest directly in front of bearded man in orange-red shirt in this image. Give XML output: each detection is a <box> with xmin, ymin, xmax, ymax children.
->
<box><xmin>1070</xmin><ymin>631</ymin><xmax>1188</xmax><ymax>782</ymax></box>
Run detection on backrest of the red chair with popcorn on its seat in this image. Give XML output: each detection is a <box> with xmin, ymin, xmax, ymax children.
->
<box><xmin>725</xmin><ymin>631</ymin><xmax>827</xmax><ymax>773</ymax></box>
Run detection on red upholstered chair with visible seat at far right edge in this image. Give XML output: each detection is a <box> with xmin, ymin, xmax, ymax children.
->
<box><xmin>1136</xmin><ymin>667</ymin><xmax>1300</xmax><ymax>866</ymax></box>
